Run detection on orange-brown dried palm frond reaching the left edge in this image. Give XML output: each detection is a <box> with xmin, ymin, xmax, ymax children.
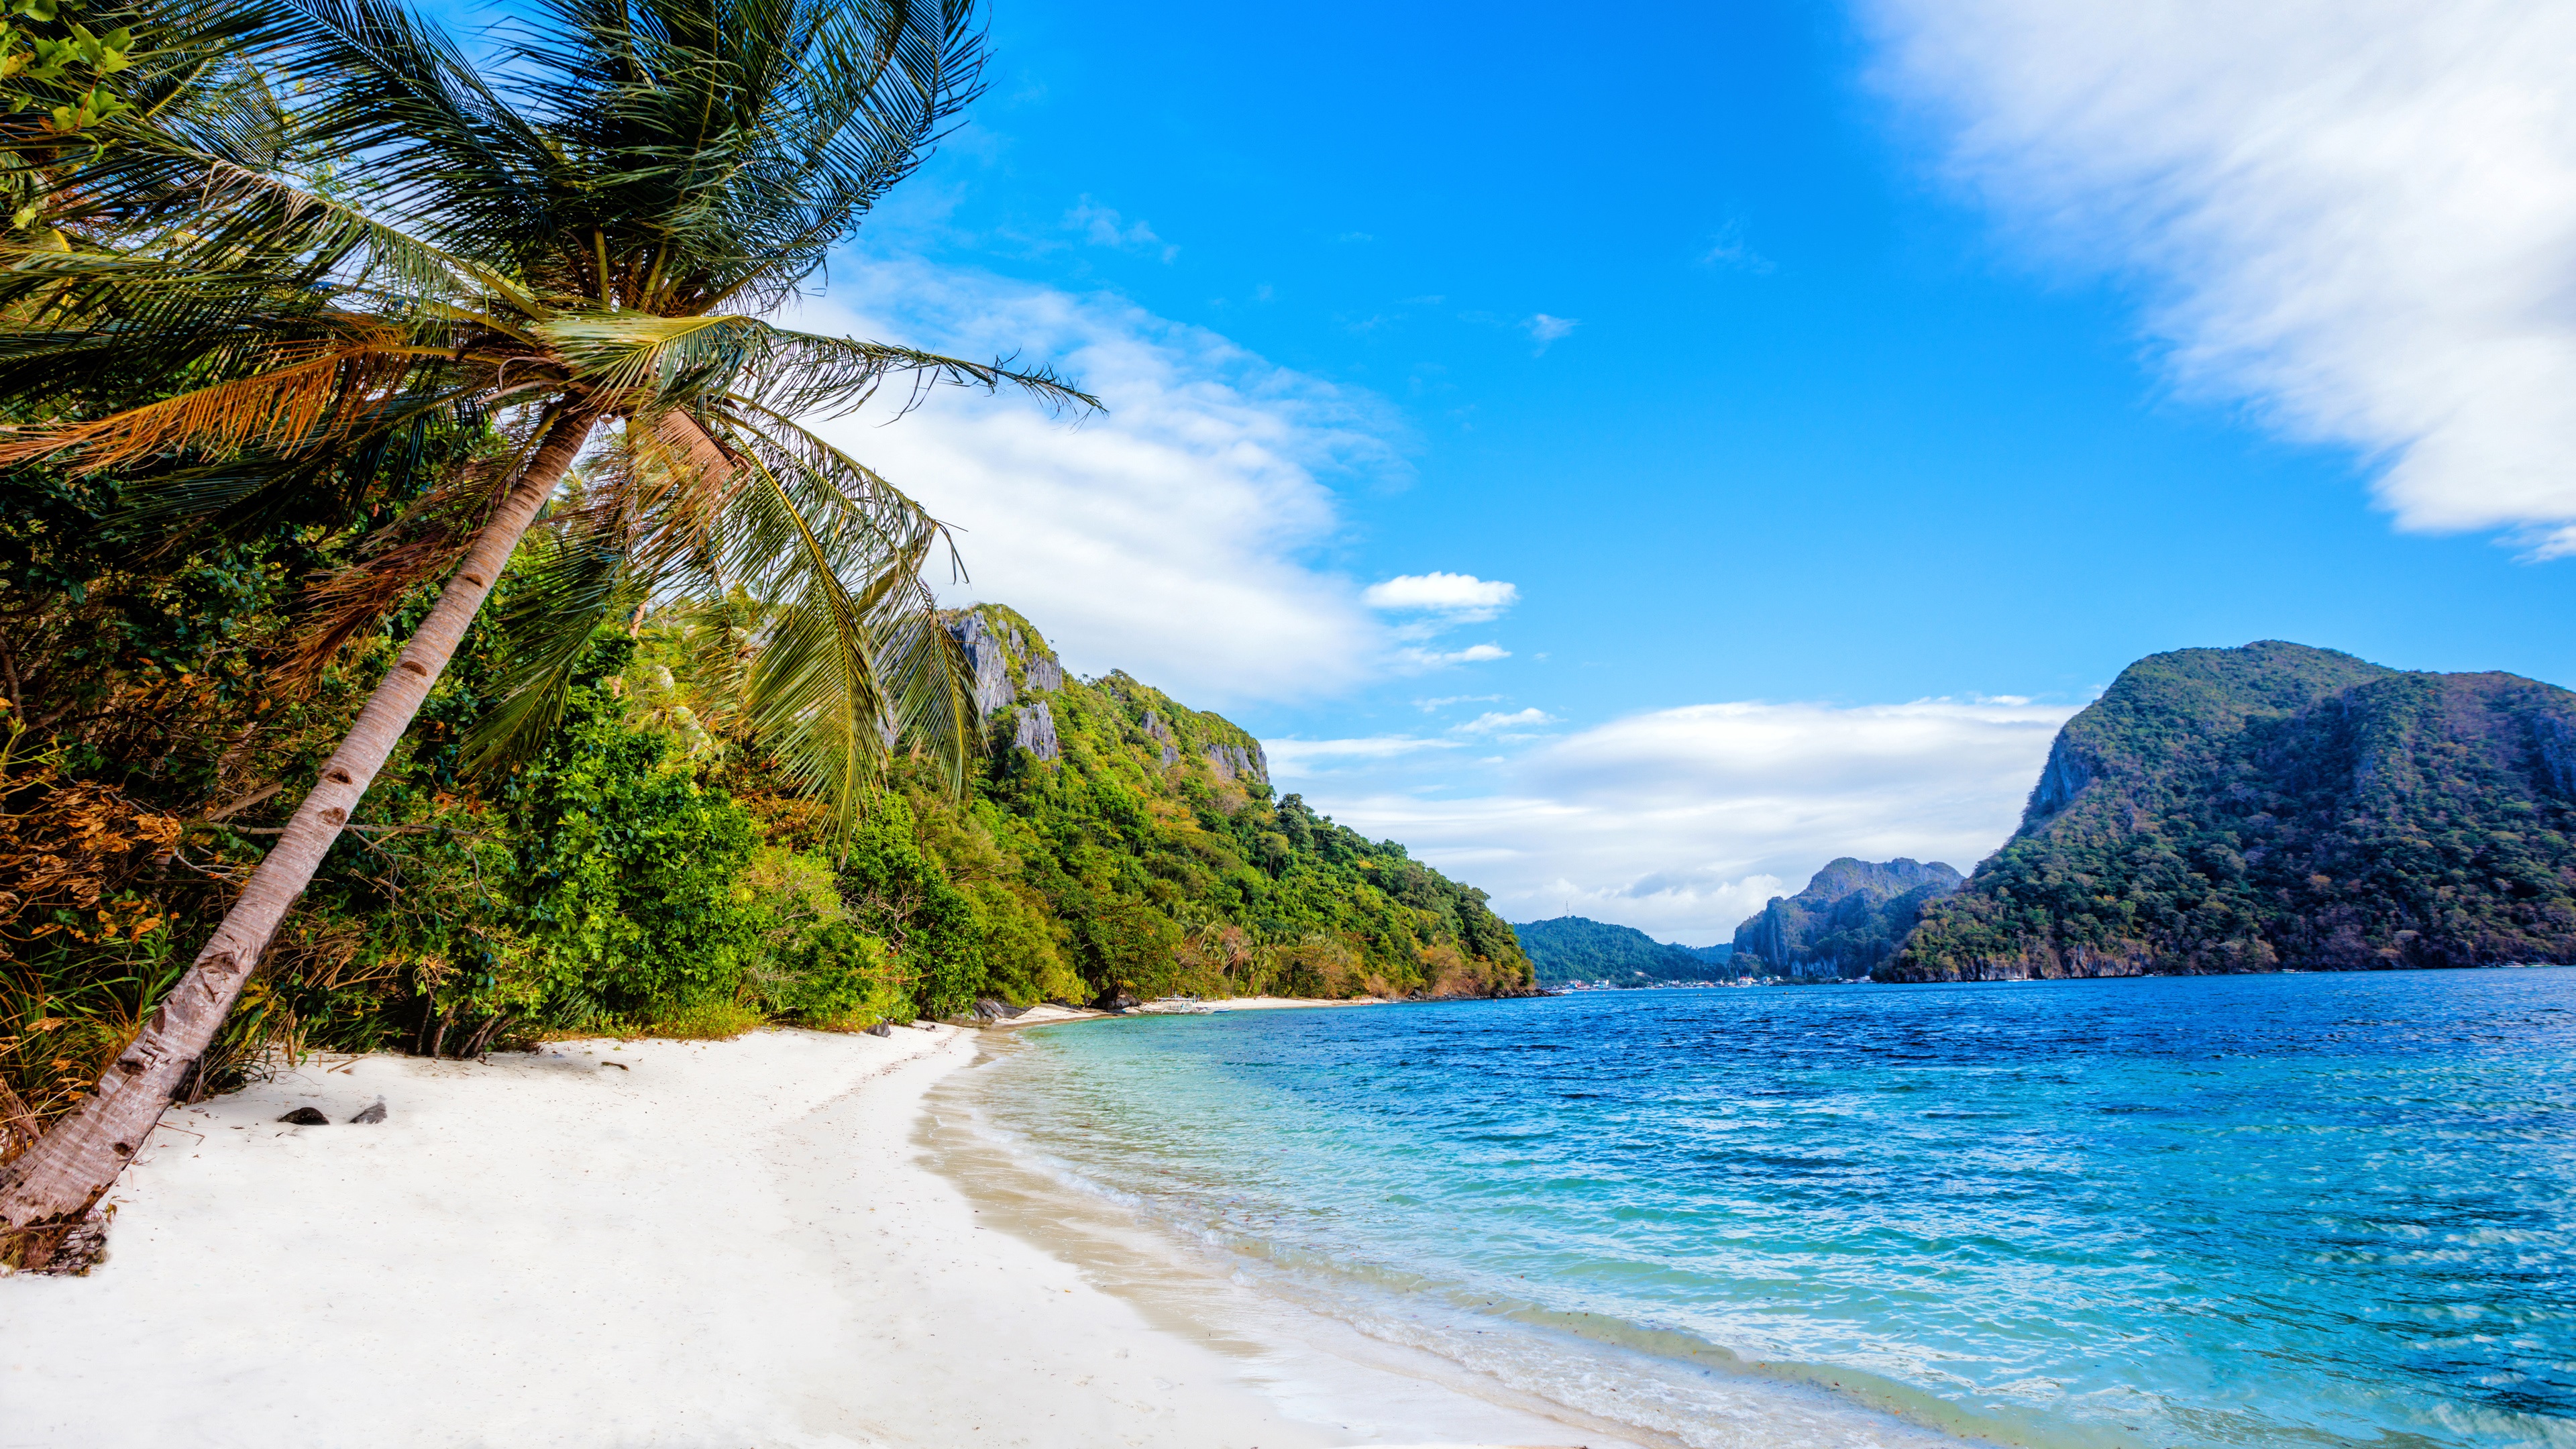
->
<box><xmin>0</xmin><ymin>333</ymin><xmax>420</xmax><ymax>474</ymax></box>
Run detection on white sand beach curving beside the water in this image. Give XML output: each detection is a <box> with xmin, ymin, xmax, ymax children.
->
<box><xmin>0</xmin><ymin>1026</ymin><xmax>1635</xmax><ymax>1449</ymax></box>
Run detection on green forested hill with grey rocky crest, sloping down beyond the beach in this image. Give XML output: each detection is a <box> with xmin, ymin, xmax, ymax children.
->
<box><xmin>910</xmin><ymin>606</ymin><xmax>1536</xmax><ymax>1000</ymax></box>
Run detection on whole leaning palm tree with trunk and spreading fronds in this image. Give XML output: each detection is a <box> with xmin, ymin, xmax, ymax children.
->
<box><xmin>0</xmin><ymin>0</ymin><xmax>1097</xmax><ymax>1230</ymax></box>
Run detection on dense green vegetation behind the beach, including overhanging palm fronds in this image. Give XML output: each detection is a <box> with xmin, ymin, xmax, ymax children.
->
<box><xmin>0</xmin><ymin>0</ymin><xmax>1530</xmax><ymax>1171</ymax></box>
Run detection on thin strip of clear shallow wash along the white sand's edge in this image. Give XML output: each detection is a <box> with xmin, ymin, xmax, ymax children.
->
<box><xmin>943</xmin><ymin>1020</ymin><xmax>1981</xmax><ymax>1449</ymax></box>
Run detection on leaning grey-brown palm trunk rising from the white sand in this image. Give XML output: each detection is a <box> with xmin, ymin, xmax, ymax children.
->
<box><xmin>0</xmin><ymin>413</ymin><xmax>598</xmax><ymax>1227</ymax></box>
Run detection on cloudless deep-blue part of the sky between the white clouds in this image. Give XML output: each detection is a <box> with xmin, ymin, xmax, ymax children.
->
<box><xmin>863</xmin><ymin>0</ymin><xmax>2576</xmax><ymax>696</ymax></box>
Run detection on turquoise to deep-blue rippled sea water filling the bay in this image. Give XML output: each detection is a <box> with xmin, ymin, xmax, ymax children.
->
<box><xmin>984</xmin><ymin>969</ymin><xmax>2576</xmax><ymax>1449</ymax></box>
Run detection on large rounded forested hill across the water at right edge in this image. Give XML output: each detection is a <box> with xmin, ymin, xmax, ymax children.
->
<box><xmin>1878</xmin><ymin>642</ymin><xmax>2576</xmax><ymax>979</ymax></box>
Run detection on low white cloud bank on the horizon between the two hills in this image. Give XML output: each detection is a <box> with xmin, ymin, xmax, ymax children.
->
<box><xmin>1288</xmin><ymin>699</ymin><xmax>2074</xmax><ymax>944</ymax></box>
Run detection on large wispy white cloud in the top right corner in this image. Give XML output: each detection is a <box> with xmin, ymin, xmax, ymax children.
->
<box><xmin>1862</xmin><ymin>0</ymin><xmax>2576</xmax><ymax>554</ymax></box>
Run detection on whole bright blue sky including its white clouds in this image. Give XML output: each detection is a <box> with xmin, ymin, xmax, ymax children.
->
<box><xmin>458</xmin><ymin>0</ymin><xmax>2576</xmax><ymax>944</ymax></box>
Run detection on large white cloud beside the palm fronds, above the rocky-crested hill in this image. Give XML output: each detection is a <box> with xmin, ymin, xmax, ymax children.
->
<box><xmin>794</xmin><ymin>263</ymin><xmax>1419</xmax><ymax>706</ymax></box>
